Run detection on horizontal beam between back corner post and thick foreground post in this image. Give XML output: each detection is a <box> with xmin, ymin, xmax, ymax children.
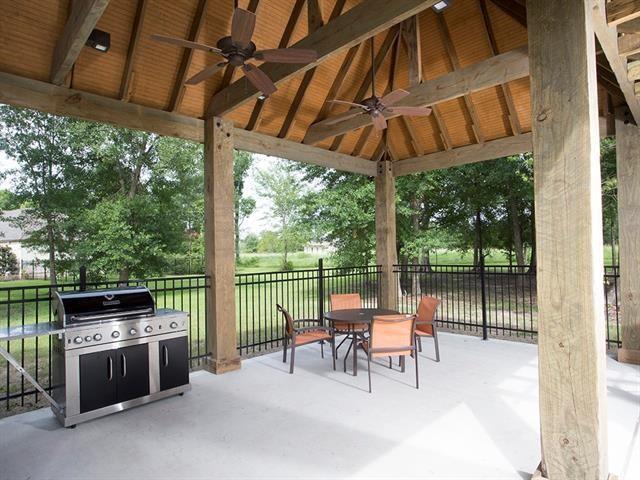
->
<box><xmin>394</xmin><ymin>133</ymin><xmax>533</xmax><ymax>177</ymax></box>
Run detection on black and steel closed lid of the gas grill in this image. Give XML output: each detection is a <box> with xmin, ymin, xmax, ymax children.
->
<box><xmin>55</xmin><ymin>286</ymin><xmax>155</xmax><ymax>327</ymax></box>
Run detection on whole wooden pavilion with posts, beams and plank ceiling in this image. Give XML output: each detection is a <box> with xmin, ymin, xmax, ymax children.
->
<box><xmin>0</xmin><ymin>0</ymin><xmax>640</xmax><ymax>480</ymax></box>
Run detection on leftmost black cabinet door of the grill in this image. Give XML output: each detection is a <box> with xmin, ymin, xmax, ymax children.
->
<box><xmin>80</xmin><ymin>350</ymin><xmax>117</xmax><ymax>413</ymax></box>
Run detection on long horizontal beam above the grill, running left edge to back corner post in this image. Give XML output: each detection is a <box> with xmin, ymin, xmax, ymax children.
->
<box><xmin>0</xmin><ymin>72</ymin><xmax>375</xmax><ymax>176</ymax></box>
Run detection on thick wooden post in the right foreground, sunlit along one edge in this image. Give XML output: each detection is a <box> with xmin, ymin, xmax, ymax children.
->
<box><xmin>527</xmin><ymin>0</ymin><xmax>607</xmax><ymax>480</ymax></box>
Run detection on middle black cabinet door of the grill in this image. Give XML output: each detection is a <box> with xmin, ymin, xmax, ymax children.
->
<box><xmin>116</xmin><ymin>344</ymin><xmax>149</xmax><ymax>402</ymax></box>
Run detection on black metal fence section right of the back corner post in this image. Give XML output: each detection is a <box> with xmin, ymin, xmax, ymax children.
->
<box><xmin>395</xmin><ymin>265</ymin><xmax>620</xmax><ymax>348</ymax></box>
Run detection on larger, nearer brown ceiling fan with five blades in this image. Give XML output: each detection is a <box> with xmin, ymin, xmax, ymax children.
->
<box><xmin>151</xmin><ymin>8</ymin><xmax>318</xmax><ymax>96</ymax></box>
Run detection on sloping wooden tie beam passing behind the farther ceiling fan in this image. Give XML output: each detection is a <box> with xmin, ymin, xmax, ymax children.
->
<box><xmin>304</xmin><ymin>47</ymin><xmax>529</xmax><ymax>144</ymax></box>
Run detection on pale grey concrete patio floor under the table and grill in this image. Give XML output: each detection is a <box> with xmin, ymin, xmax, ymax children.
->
<box><xmin>0</xmin><ymin>334</ymin><xmax>640</xmax><ymax>480</ymax></box>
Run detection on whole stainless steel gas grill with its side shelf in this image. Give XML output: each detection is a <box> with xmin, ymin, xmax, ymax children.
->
<box><xmin>0</xmin><ymin>287</ymin><xmax>191</xmax><ymax>427</ymax></box>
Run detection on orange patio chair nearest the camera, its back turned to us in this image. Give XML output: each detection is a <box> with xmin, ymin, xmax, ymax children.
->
<box><xmin>361</xmin><ymin>315</ymin><xmax>420</xmax><ymax>393</ymax></box>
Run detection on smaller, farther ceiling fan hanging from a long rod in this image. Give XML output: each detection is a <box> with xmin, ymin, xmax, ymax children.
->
<box><xmin>322</xmin><ymin>37</ymin><xmax>431</xmax><ymax>130</ymax></box>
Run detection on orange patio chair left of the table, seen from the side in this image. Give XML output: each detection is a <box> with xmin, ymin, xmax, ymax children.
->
<box><xmin>276</xmin><ymin>304</ymin><xmax>336</xmax><ymax>373</ymax></box>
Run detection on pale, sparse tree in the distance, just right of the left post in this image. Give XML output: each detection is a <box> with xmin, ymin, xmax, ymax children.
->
<box><xmin>256</xmin><ymin>160</ymin><xmax>307</xmax><ymax>269</ymax></box>
